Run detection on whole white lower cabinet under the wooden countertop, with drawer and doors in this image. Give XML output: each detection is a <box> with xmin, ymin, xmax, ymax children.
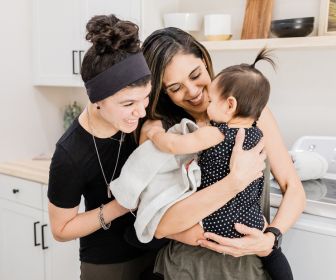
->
<box><xmin>0</xmin><ymin>174</ymin><xmax>80</xmax><ymax>280</ymax></box>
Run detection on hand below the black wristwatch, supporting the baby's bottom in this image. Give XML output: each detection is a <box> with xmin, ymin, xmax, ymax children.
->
<box><xmin>198</xmin><ymin>224</ymin><xmax>275</xmax><ymax>257</ymax></box>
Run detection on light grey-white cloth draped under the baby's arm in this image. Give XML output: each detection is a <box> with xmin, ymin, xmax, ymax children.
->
<box><xmin>110</xmin><ymin>119</ymin><xmax>201</xmax><ymax>243</ymax></box>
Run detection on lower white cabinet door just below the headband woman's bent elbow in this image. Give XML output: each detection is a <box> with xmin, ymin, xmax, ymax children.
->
<box><xmin>43</xmin><ymin>213</ymin><xmax>80</xmax><ymax>280</ymax></box>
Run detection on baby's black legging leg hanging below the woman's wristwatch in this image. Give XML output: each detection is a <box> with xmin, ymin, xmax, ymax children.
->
<box><xmin>260</xmin><ymin>248</ymin><xmax>293</xmax><ymax>280</ymax></box>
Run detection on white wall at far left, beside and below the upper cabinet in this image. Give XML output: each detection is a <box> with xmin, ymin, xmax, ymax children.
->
<box><xmin>0</xmin><ymin>0</ymin><xmax>86</xmax><ymax>161</ymax></box>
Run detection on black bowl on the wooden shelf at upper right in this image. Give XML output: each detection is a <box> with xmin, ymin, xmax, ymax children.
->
<box><xmin>271</xmin><ymin>20</ymin><xmax>314</xmax><ymax>38</ymax></box>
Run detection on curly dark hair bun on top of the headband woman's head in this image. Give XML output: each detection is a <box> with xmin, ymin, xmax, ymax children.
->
<box><xmin>86</xmin><ymin>15</ymin><xmax>140</xmax><ymax>55</ymax></box>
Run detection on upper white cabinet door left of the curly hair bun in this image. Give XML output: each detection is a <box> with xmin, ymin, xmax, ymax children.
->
<box><xmin>33</xmin><ymin>0</ymin><xmax>82</xmax><ymax>86</ymax></box>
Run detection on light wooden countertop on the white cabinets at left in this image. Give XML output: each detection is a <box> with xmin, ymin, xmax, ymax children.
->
<box><xmin>0</xmin><ymin>159</ymin><xmax>50</xmax><ymax>185</ymax></box>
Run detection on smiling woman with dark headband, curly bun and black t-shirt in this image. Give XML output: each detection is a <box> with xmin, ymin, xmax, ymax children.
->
<box><xmin>48</xmin><ymin>15</ymin><xmax>160</xmax><ymax>280</ymax></box>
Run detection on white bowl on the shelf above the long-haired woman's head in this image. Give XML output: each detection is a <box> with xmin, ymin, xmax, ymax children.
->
<box><xmin>163</xmin><ymin>13</ymin><xmax>202</xmax><ymax>31</ymax></box>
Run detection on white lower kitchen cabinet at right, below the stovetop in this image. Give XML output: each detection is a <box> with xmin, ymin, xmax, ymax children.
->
<box><xmin>271</xmin><ymin>208</ymin><xmax>336</xmax><ymax>280</ymax></box>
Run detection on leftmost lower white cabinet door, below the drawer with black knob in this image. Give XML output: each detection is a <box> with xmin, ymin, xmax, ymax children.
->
<box><xmin>0</xmin><ymin>199</ymin><xmax>45</xmax><ymax>280</ymax></box>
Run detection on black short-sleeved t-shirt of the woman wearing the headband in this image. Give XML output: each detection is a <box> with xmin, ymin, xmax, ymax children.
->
<box><xmin>48</xmin><ymin>120</ymin><xmax>145</xmax><ymax>264</ymax></box>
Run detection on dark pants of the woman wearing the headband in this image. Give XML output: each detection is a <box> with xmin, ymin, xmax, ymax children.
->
<box><xmin>80</xmin><ymin>253</ymin><xmax>161</xmax><ymax>280</ymax></box>
